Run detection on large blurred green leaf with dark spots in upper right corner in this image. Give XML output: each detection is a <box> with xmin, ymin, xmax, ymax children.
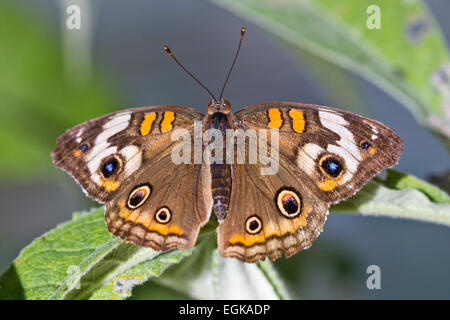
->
<box><xmin>213</xmin><ymin>0</ymin><xmax>450</xmax><ymax>141</ymax></box>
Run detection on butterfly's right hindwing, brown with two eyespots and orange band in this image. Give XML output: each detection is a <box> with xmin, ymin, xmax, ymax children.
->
<box><xmin>218</xmin><ymin>164</ymin><xmax>328</xmax><ymax>262</ymax></box>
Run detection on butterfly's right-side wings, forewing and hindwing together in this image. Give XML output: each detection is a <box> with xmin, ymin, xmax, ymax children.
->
<box><xmin>219</xmin><ymin>103</ymin><xmax>402</xmax><ymax>262</ymax></box>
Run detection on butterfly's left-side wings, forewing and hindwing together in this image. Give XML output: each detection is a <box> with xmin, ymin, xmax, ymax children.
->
<box><xmin>52</xmin><ymin>106</ymin><xmax>211</xmax><ymax>250</ymax></box>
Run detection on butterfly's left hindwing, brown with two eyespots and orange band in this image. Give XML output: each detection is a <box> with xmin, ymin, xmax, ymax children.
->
<box><xmin>105</xmin><ymin>156</ymin><xmax>212</xmax><ymax>251</ymax></box>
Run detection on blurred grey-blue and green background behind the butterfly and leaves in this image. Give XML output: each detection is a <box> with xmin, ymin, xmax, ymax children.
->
<box><xmin>0</xmin><ymin>0</ymin><xmax>450</xmax><ymax>299</ymax></box>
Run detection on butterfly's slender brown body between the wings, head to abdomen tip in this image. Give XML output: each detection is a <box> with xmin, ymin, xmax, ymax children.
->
<box><xmin>206</xmin><ymin>100</ymin><xmax>232</xmax><ymax>221</ymax></box>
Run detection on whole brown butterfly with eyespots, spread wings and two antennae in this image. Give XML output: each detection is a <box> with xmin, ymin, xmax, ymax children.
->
<box><xmin>52</xmin><ymin>28</ymin><xmax>402</xmax><ymax>262</ymax></box>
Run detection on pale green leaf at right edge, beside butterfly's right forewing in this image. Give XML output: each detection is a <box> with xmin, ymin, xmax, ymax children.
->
<box><xmin>331</xmin><ymin>170</ymin><xmax>450</xmax><ymax>226</ymax></box>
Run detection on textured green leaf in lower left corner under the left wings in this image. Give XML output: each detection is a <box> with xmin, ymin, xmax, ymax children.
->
<box><xmin>0</xmin><ymin>208</ymin><xmax>191</xmax><ymax>300</ymax></box>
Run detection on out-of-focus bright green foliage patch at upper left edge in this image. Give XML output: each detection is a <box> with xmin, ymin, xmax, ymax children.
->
<box><xmin>0</xmin><ymin>0</ymin><xmax>117</xmax><ymax>178</ymax></box>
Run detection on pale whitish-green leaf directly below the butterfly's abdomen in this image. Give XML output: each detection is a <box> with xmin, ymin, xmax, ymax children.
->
<box><xmin>153</xmin><ymin>232</ymin><xmax>289</xmax><ymax>300</ymax></box>
